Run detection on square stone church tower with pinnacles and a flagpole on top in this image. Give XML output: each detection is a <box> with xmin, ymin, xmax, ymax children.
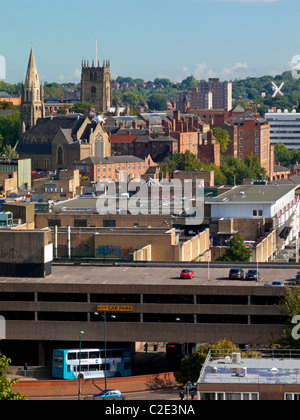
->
<box><xmin>80</xmin><ymin>60</ymin><xmax>112</xmax><ymax>112</ymax></box>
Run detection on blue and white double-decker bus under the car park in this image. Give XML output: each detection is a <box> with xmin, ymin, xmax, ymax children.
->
<box><xmin>52</xmin><ymin>349</ymin><xmax>132</xmax><ymax>379</ymax></box>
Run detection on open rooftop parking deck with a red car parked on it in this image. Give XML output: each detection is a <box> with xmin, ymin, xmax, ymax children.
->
<box><xmin>0</xmin><ymin>261</ymin><xmax>297</xmax><ymax>288</ymax></box>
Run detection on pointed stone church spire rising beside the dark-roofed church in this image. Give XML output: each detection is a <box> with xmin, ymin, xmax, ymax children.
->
<box><xmin>19</xmin><ymin>48</ymin><xmax>45</xmax><ymax>135</ymax></box>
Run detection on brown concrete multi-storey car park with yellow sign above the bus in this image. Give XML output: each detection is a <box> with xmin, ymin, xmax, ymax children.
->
<box><xmin>0</xmin><ymin>263</ymin><xmax>296</xmax><ymax>366</ymax></box>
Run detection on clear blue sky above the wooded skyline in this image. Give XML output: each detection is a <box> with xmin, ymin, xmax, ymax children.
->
<box><xmin>0</xmin><ymin>0</ymin><xmax>300</xmax><ymax>83</ymax></box>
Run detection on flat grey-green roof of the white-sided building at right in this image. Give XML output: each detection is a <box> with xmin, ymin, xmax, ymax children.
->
<box><xmin>207</xmin><ymin>183</ymin><xmax>297</xmax><ymax>204</ymax></box>
